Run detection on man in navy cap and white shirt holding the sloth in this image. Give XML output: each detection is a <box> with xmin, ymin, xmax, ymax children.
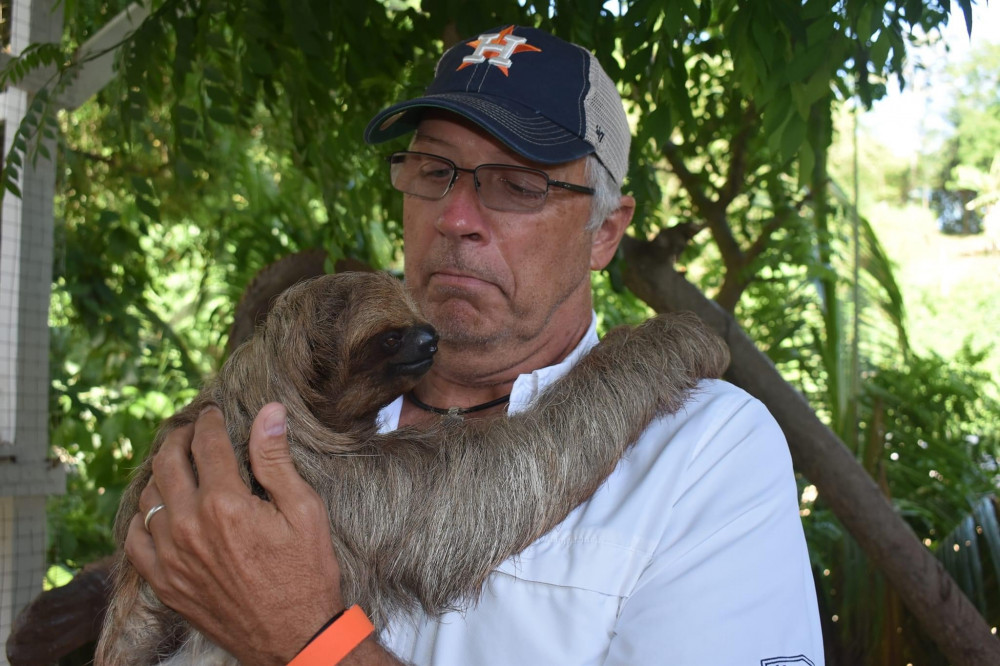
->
<box><xmin>126</xmin><ymin>26</ymin><xmax>823</xmax><ymax>666</ymax></box>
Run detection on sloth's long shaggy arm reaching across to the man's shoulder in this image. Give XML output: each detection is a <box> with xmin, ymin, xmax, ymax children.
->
<box><xmin>372</xmin><ymin>317</ymin><xmax>728</xmax><ymax>612</ymax></box>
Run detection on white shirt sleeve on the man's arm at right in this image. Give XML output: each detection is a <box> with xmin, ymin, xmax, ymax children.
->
<box><xmin>605</xmin><ymin>396</ymin><xmax>823</xmax><ymax>666</ymax></box>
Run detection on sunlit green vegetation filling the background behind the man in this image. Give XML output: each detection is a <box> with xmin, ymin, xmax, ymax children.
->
<box><xmin>4</xmin><ymin>0</ymin><xmax>1000</xmax><ymax>664</ymax></box>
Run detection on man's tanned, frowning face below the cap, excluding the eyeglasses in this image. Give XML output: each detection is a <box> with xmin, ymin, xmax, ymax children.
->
<box><xmin>403</xmin><ymin>114</ymin><xmax>593</xmax><ymax>350</ymax></box>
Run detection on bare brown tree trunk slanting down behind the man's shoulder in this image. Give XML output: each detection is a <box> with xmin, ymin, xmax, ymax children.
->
<box><xmin>622</xmin><ymin>237</ymin><xmax>1000</xmax><ymax>666</ymax></box>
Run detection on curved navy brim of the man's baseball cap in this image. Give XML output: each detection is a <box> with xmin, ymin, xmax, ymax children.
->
<box><xmin>365</xmin><ymin>92</ymin><xmax>594</xmax><ymax>164</ymax></box>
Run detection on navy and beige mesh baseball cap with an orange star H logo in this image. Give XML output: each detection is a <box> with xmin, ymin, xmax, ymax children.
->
<box><xmin>365</xmin><ymin>25</ymin><xmax>632</xmax><ymax>185</ymax></box>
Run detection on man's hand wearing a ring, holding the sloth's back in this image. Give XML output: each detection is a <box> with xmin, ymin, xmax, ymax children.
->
<box><xmin>125</xmin><ymin>403</ymin><xmax>343</xmax><ymax>664</ymax></box>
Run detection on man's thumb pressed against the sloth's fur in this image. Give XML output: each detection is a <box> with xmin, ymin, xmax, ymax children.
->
<box><xmin>250</xmin><ymin>402</ymin><xmax>309</xmax><ymax>506</ymax></box>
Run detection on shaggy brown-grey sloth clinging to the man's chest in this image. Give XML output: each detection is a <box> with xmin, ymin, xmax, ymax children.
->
<box><xmin>96</xmin><ymin>272</ymin><xmax>729</xmax><ymax>666</ymax></box>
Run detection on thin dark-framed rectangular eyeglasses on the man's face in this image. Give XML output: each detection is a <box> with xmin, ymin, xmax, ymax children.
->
<box><xmin>389</xmin><ymin>150</ymin><xmax>594</xmax><ymax>212</ymax></box>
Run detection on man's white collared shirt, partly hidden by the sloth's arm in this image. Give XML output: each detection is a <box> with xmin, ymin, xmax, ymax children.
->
<box><xmin>381</xmin><ymin>323</ymin><xmax>824</xmax><ymax>666</ymax></box>
